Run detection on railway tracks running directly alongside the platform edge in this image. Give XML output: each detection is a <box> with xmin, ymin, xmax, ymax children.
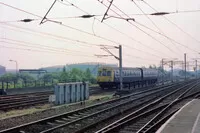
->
<box><xmin>94</xmin><ymin>80</ymin><xmax>200</xmax><ymax>133</ymax></box>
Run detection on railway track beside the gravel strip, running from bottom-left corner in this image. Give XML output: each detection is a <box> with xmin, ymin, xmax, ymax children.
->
<box><xmin>0</xmin><ymin>81</ymin><xmax>188</xmax><ymax>133</ymax></box>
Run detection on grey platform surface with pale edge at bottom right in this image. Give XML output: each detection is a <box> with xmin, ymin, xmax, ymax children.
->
<box><xmin>156</xmin><ymin>99</ymin><xmax>200</xmax><ymax>133</ymax></box>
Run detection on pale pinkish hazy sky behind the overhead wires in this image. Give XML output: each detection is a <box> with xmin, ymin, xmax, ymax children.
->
<box><xmin>0</xmin><ymin>0</ymin><xmax>200</xmax><ymax>69</ymax></box>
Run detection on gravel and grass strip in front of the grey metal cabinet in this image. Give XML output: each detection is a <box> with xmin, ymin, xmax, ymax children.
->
<box><xmin>0</xmin><ymin>93</ymin><xmax>112</xmax><ymax>130</ymax></box>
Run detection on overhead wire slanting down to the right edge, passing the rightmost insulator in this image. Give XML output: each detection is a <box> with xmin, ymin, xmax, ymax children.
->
<box><xmin>141</xmin><ymin>0</ymin><xmax>200</xmax><ymax>43</ymax></box>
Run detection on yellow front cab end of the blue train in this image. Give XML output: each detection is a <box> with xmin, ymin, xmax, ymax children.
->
<box><xmin>97</xmin><ymin>67</ymin><xmax>115</xmax><ymax>89</ymax></box>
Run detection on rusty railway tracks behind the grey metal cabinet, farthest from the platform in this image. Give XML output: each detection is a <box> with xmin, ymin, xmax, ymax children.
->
<box><xmin>0</xmin><ymin>84</ymin><xmax>172</xmax><ymax>111</ymax></box>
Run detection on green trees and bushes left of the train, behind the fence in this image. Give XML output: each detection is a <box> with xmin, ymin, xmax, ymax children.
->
<box><xmin>0</xmin><ymin>67</ymin><xmax>96</xmax><ymax>88</ymax></box>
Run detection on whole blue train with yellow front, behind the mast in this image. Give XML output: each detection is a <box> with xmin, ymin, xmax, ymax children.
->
<box><xmin>97</xmin><ymin>66</ymin><xmax>158</xmax><ymax>89</ymax></box>
